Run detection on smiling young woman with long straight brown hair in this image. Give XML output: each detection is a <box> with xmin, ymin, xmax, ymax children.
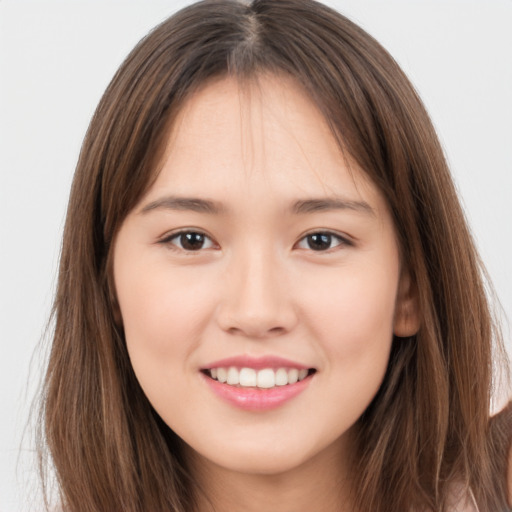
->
<box><xmin>39</xmin><ymin>0</ymin><xmax>512</xmax><ymax>512</ymax></box>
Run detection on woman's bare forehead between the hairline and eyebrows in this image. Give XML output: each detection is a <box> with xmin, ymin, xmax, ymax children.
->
<box><xmin>144</xmin><ymin>74</ymin><xmax>383</xmax><ymax>212</ymax></box>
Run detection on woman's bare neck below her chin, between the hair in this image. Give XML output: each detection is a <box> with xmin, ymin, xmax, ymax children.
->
<box><xmin>187</xmin><ymin>436</ymin><xmax>353</xmax><ymax>512</ymax></box>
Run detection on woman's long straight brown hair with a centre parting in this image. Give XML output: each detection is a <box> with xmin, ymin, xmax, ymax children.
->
<box><xmin>42</xmin><ymin>0</ymin><xmax>512</xmax><ymax>512</ymax></box>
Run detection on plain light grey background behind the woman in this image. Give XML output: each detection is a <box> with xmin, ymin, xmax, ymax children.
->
<box><xmin>0</xmin><ymin>0</ymin><xmax>512</xmax><ymax>512</ymax></box>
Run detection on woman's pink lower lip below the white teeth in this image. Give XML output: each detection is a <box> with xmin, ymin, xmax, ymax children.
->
<box><xmin>201</xmin><ymin>374</ymin><xmax>313</xmax><ymax>411</ymax></box>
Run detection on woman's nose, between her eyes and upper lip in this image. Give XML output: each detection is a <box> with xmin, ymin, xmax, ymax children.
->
<box><xmin>217</xmin><ymin>250</ymin><xmax>298</xmax><ymax>339</ymax></box>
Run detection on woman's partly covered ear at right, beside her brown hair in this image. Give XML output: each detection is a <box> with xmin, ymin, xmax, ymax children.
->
<box><xmin>393</xmin><ymin>270</ymin><xmax>421</xmax><ymax>338</ymax></box>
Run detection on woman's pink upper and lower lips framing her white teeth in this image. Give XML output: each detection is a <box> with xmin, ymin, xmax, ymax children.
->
<box><xmin>201</xmin><ymin>356</ymin><xmax>311</xmax><ymax>411</ymax></box>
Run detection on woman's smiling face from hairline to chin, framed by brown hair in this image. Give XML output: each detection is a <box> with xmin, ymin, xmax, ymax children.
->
<box><xmin>114</xmin><ymin>76</ymin><xmax>414</xmax><ymax>474</ymax></box>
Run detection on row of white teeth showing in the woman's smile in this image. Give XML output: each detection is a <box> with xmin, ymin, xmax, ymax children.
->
<box><xmin>202</xmin><ymin>366</ymin><xmax>316</xmax><ymax>389</ymax></box>
